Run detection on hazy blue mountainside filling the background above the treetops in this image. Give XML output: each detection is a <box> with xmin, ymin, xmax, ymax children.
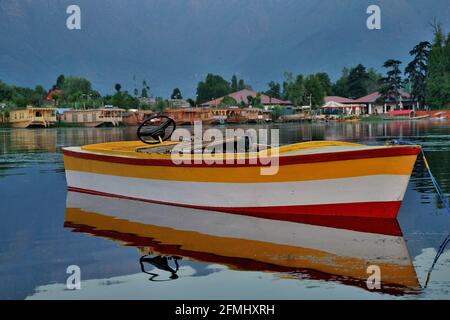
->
<box><xmin>0</xmin><ymin>0</ymin><xmax>450</xmax><ymax>97</ymax></box>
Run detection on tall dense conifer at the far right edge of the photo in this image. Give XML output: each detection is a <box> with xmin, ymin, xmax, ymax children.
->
<box><xmin>426</xmin><ymin>22</ymin><xmax>450</xmax><ymax>108</ymax></box>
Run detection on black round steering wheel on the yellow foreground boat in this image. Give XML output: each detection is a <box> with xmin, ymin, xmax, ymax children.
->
<box><xmin>137</xmin><ymin>115</ymin><xmax>176</xmax><ymax>144</ymax></box>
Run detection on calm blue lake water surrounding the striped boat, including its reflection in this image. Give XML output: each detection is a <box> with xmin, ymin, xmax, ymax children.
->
<box><xmin>0</xmin><ymin>120</ymin><xmax>450</xmax><ymax>299</ymax></box>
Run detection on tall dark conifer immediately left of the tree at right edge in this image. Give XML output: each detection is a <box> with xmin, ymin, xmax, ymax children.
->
<box><xmin>405</xmin><ymin>41</ymin><xmax>431</xmax><ymax>106</ymax></box>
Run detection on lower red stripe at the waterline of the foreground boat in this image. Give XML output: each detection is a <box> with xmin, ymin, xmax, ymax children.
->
<box><xmin>68</xmin><ymin>187</ymin><xmax>401</xmax><ymax>222</ymax></box>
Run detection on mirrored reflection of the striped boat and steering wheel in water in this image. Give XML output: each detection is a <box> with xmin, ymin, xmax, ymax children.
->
<box><xmin>65</xmin><ymin>192</ymin><xmax>420</xmax><ymax>294</ymax></box>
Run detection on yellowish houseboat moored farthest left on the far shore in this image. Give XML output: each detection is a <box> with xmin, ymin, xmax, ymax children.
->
<box><xmin>9</xmin><ymin>106</ymin><xmax>56</xmax><ymax>128</ymax></box>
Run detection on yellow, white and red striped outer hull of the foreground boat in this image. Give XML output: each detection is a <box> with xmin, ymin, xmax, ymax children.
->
<box><xmin>63</xmin><ymin>146</ymin><xmax>419</xmax><ymax>220</ymax></box>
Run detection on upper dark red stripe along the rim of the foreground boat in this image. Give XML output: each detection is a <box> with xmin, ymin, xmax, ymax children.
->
<box><xmin>62</xmin><ymin>146</ymin><xmax>420</xmax><ymax>167</ymax></box>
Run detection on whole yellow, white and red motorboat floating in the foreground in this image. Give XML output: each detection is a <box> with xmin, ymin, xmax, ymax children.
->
<box><xmin>62</xmin><ymin>118</ymin><xmax>420</xmax><ymax>218</ymax></box>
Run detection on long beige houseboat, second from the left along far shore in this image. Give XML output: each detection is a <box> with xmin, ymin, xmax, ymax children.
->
<box><xmin>61</xmin><ymin>108</ymin><xmax>125</xmax><ymax>127</ymax></box>
